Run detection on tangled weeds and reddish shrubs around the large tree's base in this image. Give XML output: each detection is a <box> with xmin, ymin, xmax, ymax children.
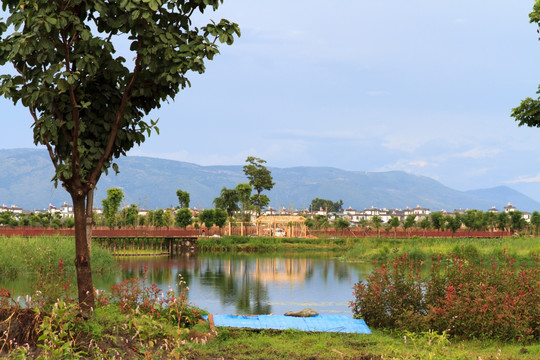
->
<box><xmin>0</xmin><ymin>268</ymin><xmax>208</xmax><ymax>359</ymax></box>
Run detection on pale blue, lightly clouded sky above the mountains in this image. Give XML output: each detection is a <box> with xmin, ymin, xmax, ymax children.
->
<box><xmin>0</xmin><ymin>0</ymin><xmax>540</xmax><ymax>200</ymax></box>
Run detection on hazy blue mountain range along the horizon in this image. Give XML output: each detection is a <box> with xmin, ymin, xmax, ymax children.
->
<box><xmin>0</xmin><ymin>149</ymin><xmax>540</xmax><ymax>211</ymax></box>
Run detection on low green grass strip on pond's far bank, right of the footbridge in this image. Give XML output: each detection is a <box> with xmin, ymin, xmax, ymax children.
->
<box><xmin>198</xmin><ymin>236</ymin><xmax>540</xmax><ymax>263</ymax></box>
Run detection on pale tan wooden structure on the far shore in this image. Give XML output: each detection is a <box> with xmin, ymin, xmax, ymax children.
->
<box><xmin>255</xmin><ymin>215</ymin><xmax>307</xmax><ymax>237</ymax></box>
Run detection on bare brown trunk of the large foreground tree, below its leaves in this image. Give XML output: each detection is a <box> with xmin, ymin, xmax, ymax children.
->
<box><xmin>71</xmin><ymin>194</ymin><xmax>95</xmax><ymax>318</ymax></box>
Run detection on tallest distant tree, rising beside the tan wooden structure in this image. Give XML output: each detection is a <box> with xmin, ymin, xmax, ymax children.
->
<box><xmin>244</xmin><ymin>156</ymin><xmax>275</xmax><ymax>216</ymax></box>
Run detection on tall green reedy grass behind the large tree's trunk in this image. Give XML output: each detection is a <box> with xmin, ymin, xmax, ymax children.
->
<box><xmin>0</xmin><ymin>236</ymin><xmax>116</xmax><ymax>278</ymax></box>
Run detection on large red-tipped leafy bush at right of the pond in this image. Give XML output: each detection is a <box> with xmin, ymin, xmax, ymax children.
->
<box><xmin>350</xmin><ymin>251</ymin><xmax>540</xmax><ymax>342</ymax></box>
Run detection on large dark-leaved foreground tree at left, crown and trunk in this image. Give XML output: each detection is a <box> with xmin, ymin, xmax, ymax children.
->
<box><xmin>0</xmin><ymin>0</ymin><xmax>240</xmax><ymax>317</ymax></box>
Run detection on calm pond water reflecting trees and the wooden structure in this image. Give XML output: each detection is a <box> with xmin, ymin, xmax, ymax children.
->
<box><xmin>4</xmin><ymin>254</ymin><xmax>372</xmax><ymax>316</ymax></box>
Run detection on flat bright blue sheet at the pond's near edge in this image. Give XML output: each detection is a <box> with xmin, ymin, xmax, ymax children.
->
<box><xmin>205</xmin><ymin>315</ymin><xmax>371</xmax><ymax>334</ymax></box>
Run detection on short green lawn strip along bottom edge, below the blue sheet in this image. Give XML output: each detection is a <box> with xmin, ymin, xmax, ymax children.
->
<box><xmin>187</xmin><ymin>329</ymin><xmax>540</xmax><ymax>360</ymax></box>
